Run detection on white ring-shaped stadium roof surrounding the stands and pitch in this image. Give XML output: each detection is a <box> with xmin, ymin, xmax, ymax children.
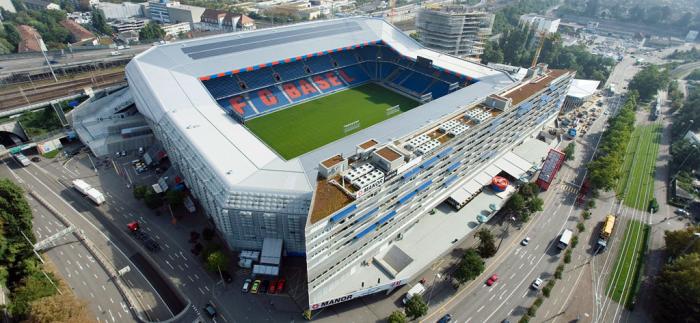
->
<box><xmin>126</xmin><ymin>17</ymin><xmax>514</xmax><ymax>193</ymax></box>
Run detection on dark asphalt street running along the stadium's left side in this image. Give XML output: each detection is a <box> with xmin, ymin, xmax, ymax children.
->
<box><xmin>14</xmin><ymin>147</ymin><xmax>301</xmax><ymax>322</ymax></box>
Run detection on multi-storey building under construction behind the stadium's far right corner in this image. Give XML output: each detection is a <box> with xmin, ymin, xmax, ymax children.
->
<box><xmin>416</xmin><ymin>5</ymin><xmax>493</xmax><ymax>57</ymax></box>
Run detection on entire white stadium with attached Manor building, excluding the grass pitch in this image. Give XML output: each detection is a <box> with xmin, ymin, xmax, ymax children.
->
<box><xmin>126</xmin><ymin>18</ymin><xmax>573</xmax><ymax>309</ymax></box>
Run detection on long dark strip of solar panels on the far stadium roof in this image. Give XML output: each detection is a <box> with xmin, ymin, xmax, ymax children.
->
<box><xmin>182</xmin><ymin>21</ymin><xmax>362</xmax><ymax>60</ymax></box>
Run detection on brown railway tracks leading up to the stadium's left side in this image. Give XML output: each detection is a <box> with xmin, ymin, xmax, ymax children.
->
<box><xmin>0</xmin><ymin>71</ymin><xmax>126</xmax><ymax>111</ymax></box>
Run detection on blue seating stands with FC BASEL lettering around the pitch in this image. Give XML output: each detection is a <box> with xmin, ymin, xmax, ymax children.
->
<box><xmin>202</xmin><ymin>44</ymin><xmax>474</xmax><ymax>122</ymax></box>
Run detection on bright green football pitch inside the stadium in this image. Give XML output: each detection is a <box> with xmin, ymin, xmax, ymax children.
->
<box><xmin>246</xmin><ymin>83</ymin><xmax>418</xmax><ymax>159</ymax></box>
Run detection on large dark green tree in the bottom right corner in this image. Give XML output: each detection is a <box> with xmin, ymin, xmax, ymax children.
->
<box><xmin>654</xmin><ymin>253</ymin><xmax>700</xmax><ymax>322</ymax></box>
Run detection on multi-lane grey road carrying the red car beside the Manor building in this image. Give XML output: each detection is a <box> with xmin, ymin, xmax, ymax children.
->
<box><xmin>424</xmin><ymin>91</ymin><xmax>619</xmax><ymax>322</ymax></box>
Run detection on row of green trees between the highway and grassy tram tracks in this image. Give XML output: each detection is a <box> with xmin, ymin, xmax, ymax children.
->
<box><xmin>586</xmin><ymin>91</ymin><xmax>638</xmax><ymax>191</ymax></box>
